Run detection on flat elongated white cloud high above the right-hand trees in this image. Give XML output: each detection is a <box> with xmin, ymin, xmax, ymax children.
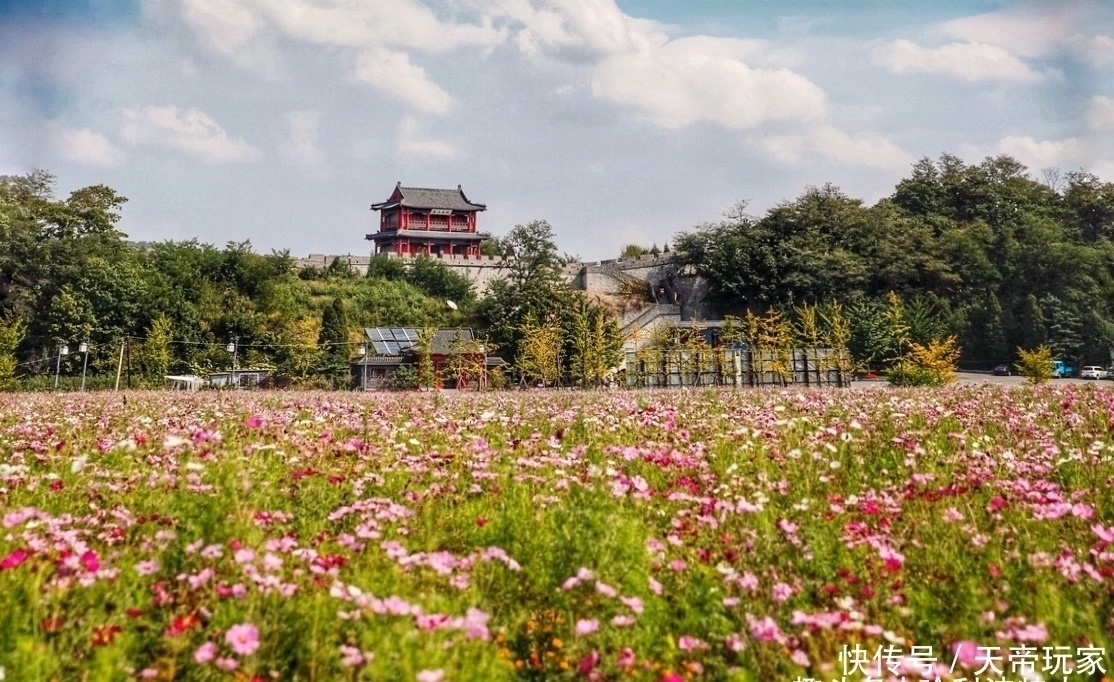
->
<box><xmin>877</xmin><ymin>40</ymin><xmax>1044</xmax><ymax>82</ymax></box>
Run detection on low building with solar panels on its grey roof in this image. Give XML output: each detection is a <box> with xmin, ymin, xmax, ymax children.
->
<box><xmin>352</xmin><ymin>327</ymin><xmax>505</xmax><ymax>389</ymax></box>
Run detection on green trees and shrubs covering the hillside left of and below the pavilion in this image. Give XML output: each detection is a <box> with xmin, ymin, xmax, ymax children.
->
<box><xmin>0</xmin><ymin>172</ymin><xmax>618</xmax><ymax>387</ymax></box>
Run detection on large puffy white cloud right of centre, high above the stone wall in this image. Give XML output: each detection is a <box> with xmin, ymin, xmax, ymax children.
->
<box><xmin>592</xmin><ymin>37</ymin><xmax>824</xmax><ymax>129</ymax></box>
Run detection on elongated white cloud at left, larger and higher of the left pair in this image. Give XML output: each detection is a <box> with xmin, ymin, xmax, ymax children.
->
<box><xmin>120</xmin><ymin>106</ymin><xmax>260</xmax><ymax>164</ymax></box>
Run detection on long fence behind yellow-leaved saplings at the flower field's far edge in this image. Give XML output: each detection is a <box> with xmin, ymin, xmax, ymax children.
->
<box><xmin>626</xmin><ymin>348</ymin><xmax>851</xmax><ymax>388</ymax></box>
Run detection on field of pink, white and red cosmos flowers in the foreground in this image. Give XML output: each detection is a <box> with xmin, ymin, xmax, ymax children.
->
<box><xmin>0</xmin><ymin>386</ymin><xmax>1114</xmax><ymax>682</ymax></box>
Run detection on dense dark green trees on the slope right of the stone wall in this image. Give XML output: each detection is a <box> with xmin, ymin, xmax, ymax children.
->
<box><xmin>674</xmin><ymin>155</ymin><xmax>1114</xmax><ymax>367</ymax></box>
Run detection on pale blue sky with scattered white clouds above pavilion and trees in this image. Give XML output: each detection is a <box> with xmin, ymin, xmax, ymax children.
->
<box><xmin>0</xmin><ymin>0</ymin><xmax>1114</xmax><ymax>259</ymax></box>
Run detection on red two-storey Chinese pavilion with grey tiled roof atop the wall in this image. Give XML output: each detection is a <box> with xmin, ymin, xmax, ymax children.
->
<box><xmin>368</xmin><ymin>183</ymin><xmax>490</xmax><ymax>256</ymax></box>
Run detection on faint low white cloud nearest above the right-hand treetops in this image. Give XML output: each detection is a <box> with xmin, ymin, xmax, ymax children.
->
<box><xmin>754</xmin><ymin>124</ymin><xmax>912</xmax><ymax>172</ymax></box>
